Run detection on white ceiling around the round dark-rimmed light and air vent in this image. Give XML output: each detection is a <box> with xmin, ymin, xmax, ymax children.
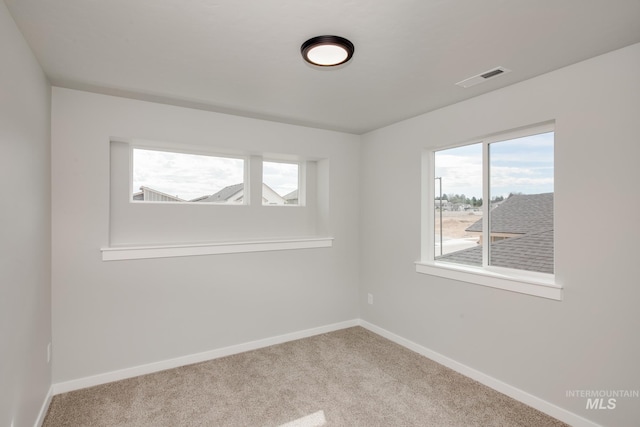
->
<box><xmin>5</xmin><ymin>0</ymin><xmax>640</xmax><ymax>134</ymax></box>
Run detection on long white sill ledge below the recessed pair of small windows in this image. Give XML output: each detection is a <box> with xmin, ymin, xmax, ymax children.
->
<box><xmin>100</xmin><ymin>237</ymin><xmax>333</xmax><ymax>261</ymax></box>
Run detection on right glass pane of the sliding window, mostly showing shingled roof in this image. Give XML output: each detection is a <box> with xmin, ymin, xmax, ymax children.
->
<box><xmin>488</xmin><ymin>132</ymin><xmax>554</xmax><ymax>273</ymax></box>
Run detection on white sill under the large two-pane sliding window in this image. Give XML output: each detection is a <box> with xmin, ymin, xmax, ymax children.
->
<box><xmin>416</xmin><ymin>262</ymin><xmax>562</xmax><ymax>301</ymax></box>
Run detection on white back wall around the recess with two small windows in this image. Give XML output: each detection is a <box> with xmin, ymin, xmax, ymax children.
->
<box><xmin>52</xmin><ymin>88</ymin><xmax>360</xmax><ymax>383</ymax></box>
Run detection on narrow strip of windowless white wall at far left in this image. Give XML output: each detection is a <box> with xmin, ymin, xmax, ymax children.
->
<box><xmin>0</xmin><ymin>1</ymin><xmax>51</xmax><ymax>427</ymax></box>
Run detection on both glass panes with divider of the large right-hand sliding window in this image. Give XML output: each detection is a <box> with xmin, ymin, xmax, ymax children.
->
<box><xmin>433</xmin><ymin>128</ymin><xmax>554</xmax><ymax>274</ymax></box>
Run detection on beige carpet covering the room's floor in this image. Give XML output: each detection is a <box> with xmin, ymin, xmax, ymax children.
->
<box><xmin>44</xmin><ymin>327</ymin><xmax>565</xmax><ymax>427</ymax></box>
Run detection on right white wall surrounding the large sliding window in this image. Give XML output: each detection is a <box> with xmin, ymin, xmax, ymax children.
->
<box><xmin>360</xmin><ymin>45</ymin><xmax>640</xmax><ymax>426</ymax></box>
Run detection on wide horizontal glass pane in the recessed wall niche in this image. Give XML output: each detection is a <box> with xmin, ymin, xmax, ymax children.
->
<box><xmin>132</xmin><ymin>148</ymin><xmax>244</xmax><ymax>203</ymax></box>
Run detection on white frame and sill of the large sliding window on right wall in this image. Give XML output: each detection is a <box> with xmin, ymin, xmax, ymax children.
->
<box><xmin>416</xmin><ymin>122</ymin><xmax>562</xmax><ymax>301</ymax></box>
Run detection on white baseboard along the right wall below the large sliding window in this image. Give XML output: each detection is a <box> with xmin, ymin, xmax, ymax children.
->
<box><xmin>360</xmin><ymin>320</ymin><xmax>600</xmax><ymax>427</ymax></box>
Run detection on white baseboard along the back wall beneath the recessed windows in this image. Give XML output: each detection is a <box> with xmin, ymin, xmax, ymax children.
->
<box><xmin>52</xmin><ymin>319</ymin><xmax>360</xmax><ymax>395</ymax></box>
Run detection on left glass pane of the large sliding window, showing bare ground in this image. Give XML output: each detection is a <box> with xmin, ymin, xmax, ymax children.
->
<box><xmin>434</xmin><ymin>143</ymin><xmax>482</xmax><ymax>266</ymax></box>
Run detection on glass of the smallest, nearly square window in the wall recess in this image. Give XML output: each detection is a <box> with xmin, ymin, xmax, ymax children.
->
<box><xmin>262</xmin><ymin>162</ymin><xmax>299</xmax><ymax>205</ymax></box>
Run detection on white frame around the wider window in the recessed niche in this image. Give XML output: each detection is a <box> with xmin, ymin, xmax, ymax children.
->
<box><xmin>129</xmin><ymin>141</ymin><xmax>251</xmax><ymax>206</ymax></box>
